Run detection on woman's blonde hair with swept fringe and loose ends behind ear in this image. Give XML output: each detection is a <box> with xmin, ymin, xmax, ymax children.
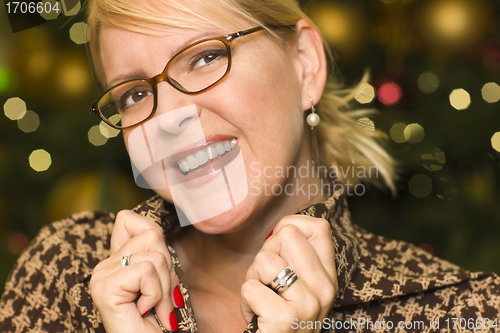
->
<box><xmin>87</xmin><ymin>0</ymin><xmax>397</xmax><ymax>193</ymax></box>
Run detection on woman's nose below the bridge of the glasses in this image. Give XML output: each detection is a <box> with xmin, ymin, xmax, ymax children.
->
<box><xmin>155</xmin><ymin>84</ymin><xmax>199</xmax><ymax>135</ymax></box>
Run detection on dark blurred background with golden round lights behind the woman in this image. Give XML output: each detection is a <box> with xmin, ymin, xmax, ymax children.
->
<box><xmin>0</xmin><ymin>0</ymin><xmax>500</xmax><ymax>292</ymax></box>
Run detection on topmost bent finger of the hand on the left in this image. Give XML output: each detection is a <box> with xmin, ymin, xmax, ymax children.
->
<box><xmin>110</xmin><ymin>210</ymin><xmax>163</xmax><ymax>254</ymax></box>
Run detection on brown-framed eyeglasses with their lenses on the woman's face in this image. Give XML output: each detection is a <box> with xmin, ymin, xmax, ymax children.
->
<box><xmin>89</xmin><ymin>26</ymin><xmax>264</xmax><ymax>129</ymax></box>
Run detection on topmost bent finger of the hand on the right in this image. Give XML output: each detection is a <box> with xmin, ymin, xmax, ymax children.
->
<box><xmin>271</xmin><ymin>215</ymin><xmax>337</xmax><ymax>281</ymax></box>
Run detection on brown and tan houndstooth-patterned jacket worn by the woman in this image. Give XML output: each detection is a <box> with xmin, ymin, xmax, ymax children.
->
<box><xmin>0</xmin><ymin>191</ymin><xmax>500</xmax><ymax>333</ymax></box>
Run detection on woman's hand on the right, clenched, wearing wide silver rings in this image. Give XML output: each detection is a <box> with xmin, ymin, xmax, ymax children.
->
<box><xmin>241</xmin><ymin>215</ymin><xmax>338</xmax><ymax>333</ymax></box>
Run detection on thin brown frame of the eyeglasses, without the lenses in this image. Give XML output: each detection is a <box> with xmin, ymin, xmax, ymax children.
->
<box><xmin>89</xmin><ymin>26</ymin><xmax>265</xmax><ymax>130</ymax></box>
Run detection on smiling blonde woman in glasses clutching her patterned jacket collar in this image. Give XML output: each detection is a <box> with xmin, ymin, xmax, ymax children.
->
<box><xmin>0</xmin><ymin>0</ymin><xmax>500</xmax><ymax>333</ymax></box>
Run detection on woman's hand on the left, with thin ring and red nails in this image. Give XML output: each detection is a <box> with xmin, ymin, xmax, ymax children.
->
<box><xmin>90</xmin><ymin>210</ymin><xmax>184</xmax><ymax>333</ymax></box>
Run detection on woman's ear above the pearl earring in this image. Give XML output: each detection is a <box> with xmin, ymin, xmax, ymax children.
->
<box><xmin>295</xmin><ymin>19</ymin><xmax>327</xmax><ymax>111</ymax></box>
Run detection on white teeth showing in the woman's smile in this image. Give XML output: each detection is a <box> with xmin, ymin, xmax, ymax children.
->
<box><xmin>176</xmin><ymin>139</ymin><xmax>237</xmax><ymax>175</ymax></box>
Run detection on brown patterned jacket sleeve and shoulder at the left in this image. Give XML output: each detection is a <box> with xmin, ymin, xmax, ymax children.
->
<box><xmin>0</xmin><ymin>212</ymin><xmax>113</xmax><ymax>333</ymax></box>
